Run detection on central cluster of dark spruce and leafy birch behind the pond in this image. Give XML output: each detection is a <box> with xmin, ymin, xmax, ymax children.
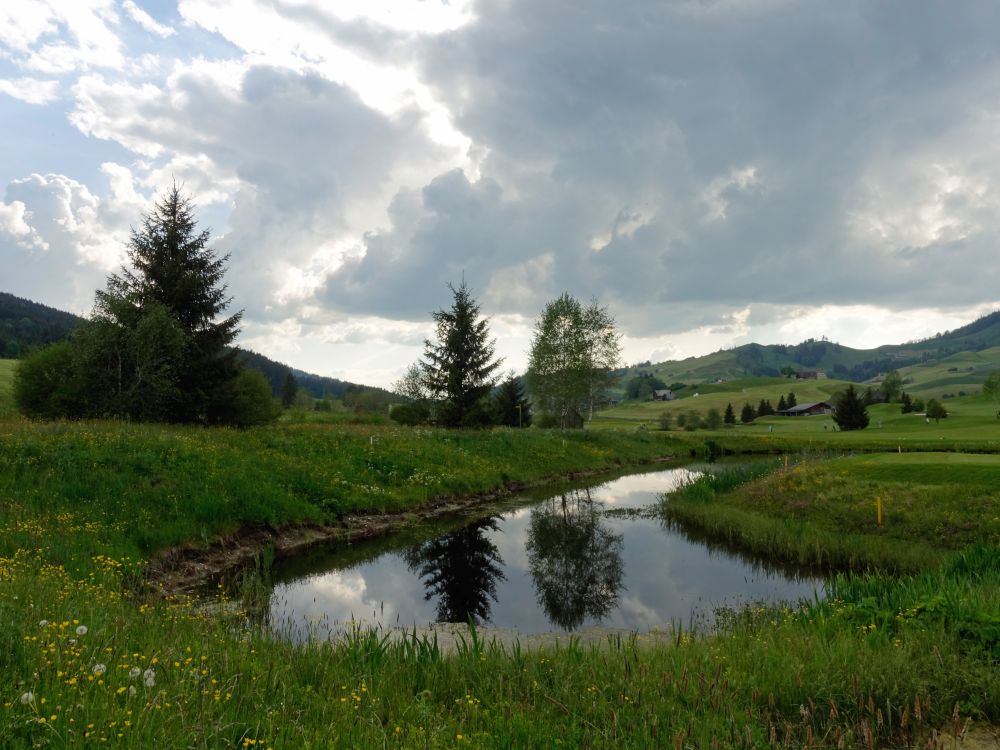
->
<box><xmin>391</xmin><ymin>280</ymin><xmax>621</xmax><ymax>427</ymax></box>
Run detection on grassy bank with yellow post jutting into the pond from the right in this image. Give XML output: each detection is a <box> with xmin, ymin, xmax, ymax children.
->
<box><xmin>664</xmin><ymin>453</ymin><xmax>1000</xmax><ymax>572</ymax></box>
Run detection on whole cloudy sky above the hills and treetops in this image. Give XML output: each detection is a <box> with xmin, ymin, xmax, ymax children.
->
<box><xmin>0</xmin><ymin>0</ymin><xmax>1000</xmax><ymax>386</ymax></box>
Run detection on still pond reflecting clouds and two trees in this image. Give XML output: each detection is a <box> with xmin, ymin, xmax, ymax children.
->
<box><xmin>254</xmin><ymin>467</ymin><xmax>823</xmax><ymax>640</ymax></box>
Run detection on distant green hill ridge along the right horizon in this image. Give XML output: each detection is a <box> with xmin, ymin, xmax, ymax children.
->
<box><xmin>620</xmin><ymin>311</ymin><xmax>1000</xmax><ymax>383</ymax></box>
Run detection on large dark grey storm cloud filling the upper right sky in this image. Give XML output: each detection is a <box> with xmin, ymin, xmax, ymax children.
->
<box><xmin>316</xmin><ymin>0</ymin><xmax>1000</xmax><ymax>333</ymax></box>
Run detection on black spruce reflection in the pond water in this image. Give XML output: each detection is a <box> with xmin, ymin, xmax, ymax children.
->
<box><xmin>404</xmin><ymin>517</ymin><xmax>505</xmax><ymax>622</ymax></box>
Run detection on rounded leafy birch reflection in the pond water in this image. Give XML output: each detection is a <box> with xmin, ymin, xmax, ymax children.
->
<box><xmin>527</xmin><ymin>490</ymin><xmax>624</xmax><ymax>630</ymax></box>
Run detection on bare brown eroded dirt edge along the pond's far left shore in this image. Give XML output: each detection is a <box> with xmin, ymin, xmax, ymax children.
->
<box><xmin>145</xmin><ymin>456</ymin><xmax>675</xmax><ymax>595</ymax></box>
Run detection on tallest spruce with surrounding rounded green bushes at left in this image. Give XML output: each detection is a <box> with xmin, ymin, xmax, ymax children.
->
<box><xmin>14</xmin><ymin>186</ymin><xmax>277</xmax><ymax>426</ymax></box>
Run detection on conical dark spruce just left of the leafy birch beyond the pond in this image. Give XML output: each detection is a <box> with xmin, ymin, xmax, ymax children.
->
<box><xmin>421</xmin><ymin>280</ymin><xmax>501</xmax><ymax>427</ymax></box>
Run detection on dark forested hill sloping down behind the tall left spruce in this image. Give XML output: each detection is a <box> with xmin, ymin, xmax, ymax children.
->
<box><xmin>0</xmin><ymin>292</ymin><xmax>392</xmax><ymax>401</ymax></box>
